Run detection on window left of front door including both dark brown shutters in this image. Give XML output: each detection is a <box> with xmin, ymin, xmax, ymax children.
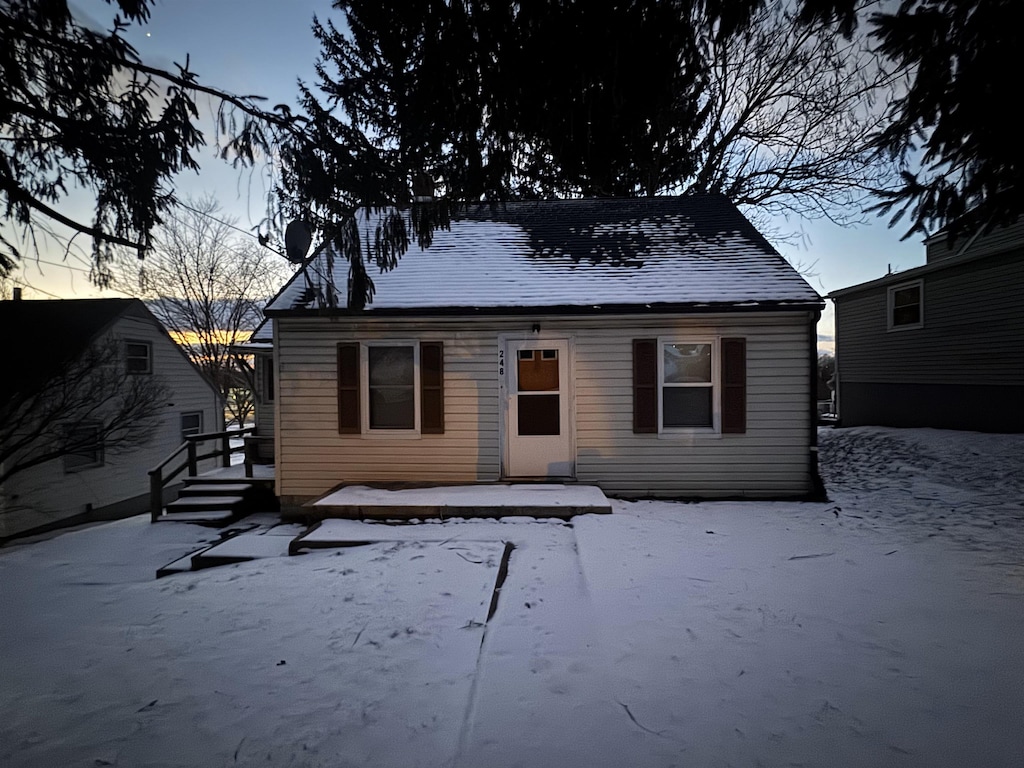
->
<box><xmin>338</xmin><ymin>341</ymin><xmax>444</xmax><ymax>434</ymax></box>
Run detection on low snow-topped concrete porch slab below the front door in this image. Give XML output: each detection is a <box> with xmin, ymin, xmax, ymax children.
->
<box><xmin>303</xmin><ymin>483</ymin><xmax>611</xmax><ymax>520</ymax></box>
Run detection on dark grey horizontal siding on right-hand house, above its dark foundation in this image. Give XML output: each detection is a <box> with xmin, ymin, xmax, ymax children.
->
<box><xmin>836</xmin><ymin>252</ymin><xmax>1024</xmax><ymax>385</ymax></box>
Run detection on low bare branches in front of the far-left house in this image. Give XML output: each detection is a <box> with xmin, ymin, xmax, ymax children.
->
<box><xmin>0</xmin><ymin>338</ymin><xmax>169</xmax><ymax>484</ymax></box>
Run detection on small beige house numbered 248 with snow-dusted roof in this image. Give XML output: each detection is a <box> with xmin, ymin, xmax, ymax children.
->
<box><xmin>260</xmin><ymin>196</ymin><xmax>823</xmax><ymax>504</ymax></box>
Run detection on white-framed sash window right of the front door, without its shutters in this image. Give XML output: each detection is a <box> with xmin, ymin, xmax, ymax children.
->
<box><xmin>658</xmin><ymin>341</ymin><xmax>718</xmax><ymax>431</ymax></box>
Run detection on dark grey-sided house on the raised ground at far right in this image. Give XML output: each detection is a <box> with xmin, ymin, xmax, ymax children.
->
<box><xmin>829</xmin><ymin>221</ymin><xmax>1024</xmax><ymax>432</ymax></box>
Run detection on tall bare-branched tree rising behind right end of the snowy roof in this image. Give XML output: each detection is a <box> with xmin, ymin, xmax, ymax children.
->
<box><xmin>682</xmin><ymin>0</ymin><xmax>904</xmax><ymax>236</ymax></box>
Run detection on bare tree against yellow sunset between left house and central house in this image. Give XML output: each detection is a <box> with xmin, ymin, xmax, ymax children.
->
<box><xmin>111</xmin><ymin>197</ymin><xmax>289</xmax><ymax>425</ymax></box>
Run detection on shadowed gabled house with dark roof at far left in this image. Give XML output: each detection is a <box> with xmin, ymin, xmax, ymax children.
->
<box><xmin>0</xmin><ymin>299</ymin><xmax>223</xmax><ymax>538</ymax></box>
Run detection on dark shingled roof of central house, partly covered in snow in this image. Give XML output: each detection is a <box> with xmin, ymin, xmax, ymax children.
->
<box><xmin>266</xmin><ymin>195</ymin><xmax>821</xmax><ymax>314</ymax></box>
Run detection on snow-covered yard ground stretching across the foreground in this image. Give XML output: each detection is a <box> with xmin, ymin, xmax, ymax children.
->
<box><xmin>0</xmin><ymin>428</ymin><xmax>1024</xmax><ymax>768</ymax></box>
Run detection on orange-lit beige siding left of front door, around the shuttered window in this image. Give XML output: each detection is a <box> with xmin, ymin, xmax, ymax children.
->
<box><xmin>276</xmin><ymin>319</ymin><xmax>500</xmax><ymax>500</ymax></box>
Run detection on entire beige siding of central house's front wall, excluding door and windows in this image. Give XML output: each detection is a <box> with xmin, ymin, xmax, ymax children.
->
<box><xmin>275</xmin><ymin>312</ymin><xmax>813</xmax><ymax>503</ymax></box>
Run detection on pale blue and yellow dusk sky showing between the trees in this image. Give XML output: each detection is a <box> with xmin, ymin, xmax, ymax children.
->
<box><xmin>20</xmin><ymin>0</ymin><xmax>925</xmax><ymax>346</ymax></box>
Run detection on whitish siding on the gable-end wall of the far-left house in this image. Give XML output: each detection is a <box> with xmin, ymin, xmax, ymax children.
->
<box><xmin>4</xmin><ymin>316</ymin><xmax>223</xmax><ymax>522</ymax></box>
